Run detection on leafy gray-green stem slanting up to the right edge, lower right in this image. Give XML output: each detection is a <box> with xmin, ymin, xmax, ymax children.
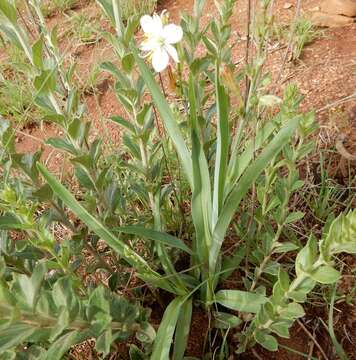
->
<box><xmin>239</xmin><ymin>210</ymin><xmax>356</xmax><ymax>352</ymax></box>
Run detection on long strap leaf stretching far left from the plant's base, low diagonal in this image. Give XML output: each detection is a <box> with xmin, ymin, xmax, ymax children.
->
<box><xmin>37</xmin><ymin>163</ymin><xmax>179</xmax><ymax>293</ymax></box>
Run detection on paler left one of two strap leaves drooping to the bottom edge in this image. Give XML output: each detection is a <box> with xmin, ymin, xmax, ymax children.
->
<box><xmin>150</xmin><ymin>297</ymin><xmax>186</xmax><ymax>360</ymax></box>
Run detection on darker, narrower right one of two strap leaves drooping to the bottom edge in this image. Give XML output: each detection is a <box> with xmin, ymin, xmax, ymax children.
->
<box><xmin>172</xmin><ymin>298</ymin><xmax>193</xmax><ymax>360</ymax></box>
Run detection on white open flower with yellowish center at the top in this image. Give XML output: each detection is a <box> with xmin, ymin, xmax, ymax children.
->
<box><xmin>140</xmin><ymin>12</ymin><xmax>183</xmax><ymax>72</ymax></box>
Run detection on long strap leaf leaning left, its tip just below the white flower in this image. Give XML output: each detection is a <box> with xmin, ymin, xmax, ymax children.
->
<box><xmin>132</xmin><ymin>47</ymin><xmax>193</xmax><ymax>185</ymax></box>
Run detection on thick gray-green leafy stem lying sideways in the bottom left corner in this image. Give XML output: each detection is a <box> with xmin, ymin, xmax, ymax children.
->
<box><xmin>0</xmin><ymin>262</ymin><xmax>154</xmax><ymax>360</ymax></box>
